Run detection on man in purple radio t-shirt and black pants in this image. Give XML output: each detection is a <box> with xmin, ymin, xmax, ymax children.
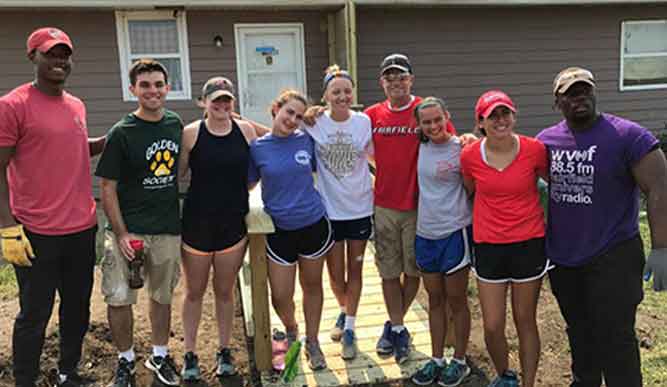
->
<box><xmin>537</xmin><ymin>67</ymin><xmax>667</xmax><ymax>387</ymax></box>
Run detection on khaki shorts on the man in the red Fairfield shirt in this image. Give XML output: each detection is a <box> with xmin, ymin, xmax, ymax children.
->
<box><xmin>375</xmin><ymin>206</ymin><xmax>419</xmax><ymax>279</ymax></box>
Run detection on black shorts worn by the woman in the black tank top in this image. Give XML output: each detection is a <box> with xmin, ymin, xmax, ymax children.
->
<box><xmin>181</xmin><ymin>214</ymin><xmax>248</xmax><ymax>253</ymax></box>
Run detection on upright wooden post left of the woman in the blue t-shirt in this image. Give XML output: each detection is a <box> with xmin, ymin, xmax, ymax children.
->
<box><xmin>249</xmin><ymin>234</ymin><xmax>272</xmax><ymax>372</ymax></box>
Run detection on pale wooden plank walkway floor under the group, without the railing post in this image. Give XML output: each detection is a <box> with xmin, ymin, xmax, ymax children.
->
<box><xmin>262</xmin><ymin>250</ymin><xmax>448</xmax><ymax>386</ymax></box>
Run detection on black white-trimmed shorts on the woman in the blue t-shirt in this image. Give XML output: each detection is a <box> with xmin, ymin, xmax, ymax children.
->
<box><xmin>266</xmin><ymin>217</ymin><xmax>334</xmax><ymax>266</ymax></box>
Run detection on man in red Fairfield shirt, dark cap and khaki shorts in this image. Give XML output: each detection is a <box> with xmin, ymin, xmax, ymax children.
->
<box><xmin>365</xmin><ymin>54</ymin><xmax>456</xmax><ymax>363</ymax></box>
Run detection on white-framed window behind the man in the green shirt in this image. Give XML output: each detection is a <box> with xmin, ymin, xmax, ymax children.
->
<box><xmin>116</xmin><ymin>11</ymin><xmax>191</xmax><ymax>101</ymax></box>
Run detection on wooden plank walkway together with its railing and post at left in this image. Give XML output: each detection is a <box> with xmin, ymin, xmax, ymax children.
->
<box><xmin>239</xmin><ymin>187</ymin><xmax>453</xmax><ymax>386</ymax></box>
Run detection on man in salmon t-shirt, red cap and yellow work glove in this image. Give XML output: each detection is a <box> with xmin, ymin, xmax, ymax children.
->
<box><xmin>0</xmin><ymin>27</ymin><xmax>104</xmax><ymax>387</ymax></box>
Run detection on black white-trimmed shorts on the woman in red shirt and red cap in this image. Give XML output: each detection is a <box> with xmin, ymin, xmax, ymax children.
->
<box><xmin>473</xmin><ymin>238</ymin><xmax>551</xmax><ymax>283</ymax></box>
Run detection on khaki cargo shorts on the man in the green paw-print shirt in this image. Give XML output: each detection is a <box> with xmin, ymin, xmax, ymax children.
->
<box><xmin>101</xmin><ymin>230</ymin><xmax>181</xmax><ymax>306</ymax></box>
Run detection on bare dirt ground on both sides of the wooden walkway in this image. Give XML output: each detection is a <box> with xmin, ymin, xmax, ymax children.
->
<box><xmin>0</xmin><ymin>272</ymin><xmax>662</xmax><ymax>387</ymax></box>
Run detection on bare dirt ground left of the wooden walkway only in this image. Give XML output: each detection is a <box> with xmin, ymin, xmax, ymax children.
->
<box><xmin>0</xmin><ymin>270</ymin><xmax>252</xmax><ymax>387</ymax></box>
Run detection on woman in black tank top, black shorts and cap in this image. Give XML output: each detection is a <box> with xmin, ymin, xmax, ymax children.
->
<box><xmin>179</xmin><ymin>77</ymin><xmax>255</xmax><ymax>382</ymax></box>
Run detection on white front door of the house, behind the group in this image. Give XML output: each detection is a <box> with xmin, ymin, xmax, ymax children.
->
<box><xmin>234</xmin><ymin>23</ymin><xmax>306</xmax><ymax>126</ymax></box>
